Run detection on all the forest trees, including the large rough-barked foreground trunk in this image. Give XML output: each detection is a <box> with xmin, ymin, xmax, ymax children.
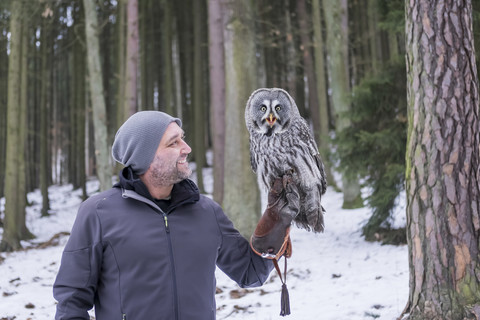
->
<box><xmin>0</xmin><ymin>0</ymin><xmax>480</xmax><ymax>319</ymax></box>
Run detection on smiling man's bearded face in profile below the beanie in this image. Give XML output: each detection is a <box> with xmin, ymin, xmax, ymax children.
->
<box><xmin>145</xmin><ymin>122</ymin><xmax>192</xmax><ymax>187</ymax></box>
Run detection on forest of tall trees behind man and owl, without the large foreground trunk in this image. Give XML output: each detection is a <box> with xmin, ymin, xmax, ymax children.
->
<box><xmin>0</xmin><ymin>0</ymin><xmax>480</xmax><ymax>251</ymax></box>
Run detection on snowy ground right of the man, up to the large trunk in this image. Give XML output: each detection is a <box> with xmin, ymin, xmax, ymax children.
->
<box><xmin>217</xmin><ymin>190</ymin><xmax>408</xmax><ymax>320</ymax></box>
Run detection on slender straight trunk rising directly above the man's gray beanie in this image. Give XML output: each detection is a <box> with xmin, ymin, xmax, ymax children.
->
<box><xmin>123</xmin><ymin>0</ymin><xmax>139</xmax><ymax>117</ymax></box>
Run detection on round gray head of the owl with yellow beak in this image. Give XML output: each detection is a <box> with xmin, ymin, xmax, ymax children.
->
<box><xmin>245</xmin><ymin>88</ymin><xmax>299</xmax><ymax>136</ymax></box>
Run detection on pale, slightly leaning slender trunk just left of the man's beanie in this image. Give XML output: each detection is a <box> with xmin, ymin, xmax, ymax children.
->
<box><xmin>83</xmin><ymin>0</ymin><xmax>112</xmax><ymax>191</ymax></box>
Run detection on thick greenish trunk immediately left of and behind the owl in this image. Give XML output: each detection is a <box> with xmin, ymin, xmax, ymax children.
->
<box><xmin>223</xmin><ymin>0</ymin><xmax>260</xmax><ymax>238</ymax></box>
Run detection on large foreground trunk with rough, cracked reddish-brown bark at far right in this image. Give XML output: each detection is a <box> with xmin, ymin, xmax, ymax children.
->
<box><xmin>405</xmin><ymin>0</ymin><xmax>480</xmax><ymax>320</ymax></box>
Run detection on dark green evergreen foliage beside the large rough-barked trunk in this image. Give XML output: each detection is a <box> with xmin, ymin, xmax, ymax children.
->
<box><xmin>335</xmin><ymin>60</ymin><xmax>407</xmax><ymax>240</ymax></box>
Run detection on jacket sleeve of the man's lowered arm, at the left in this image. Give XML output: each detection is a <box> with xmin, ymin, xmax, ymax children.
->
<box><xmin>53</xmin><ymin>198</ymin><xmax>103</xmax><ymax>320</ymax></box>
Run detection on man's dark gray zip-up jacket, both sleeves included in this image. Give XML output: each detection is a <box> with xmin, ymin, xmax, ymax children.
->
<box><xmin>53</xmin><ymin>174</ymin><xmax>273</xmax><ymax>320</ymax></box>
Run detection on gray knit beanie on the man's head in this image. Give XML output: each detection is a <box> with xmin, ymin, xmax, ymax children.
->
<box><xmin>112</xmin><ymin>111</ymin><xmax>182</xmax><ymax>175</ymax></box>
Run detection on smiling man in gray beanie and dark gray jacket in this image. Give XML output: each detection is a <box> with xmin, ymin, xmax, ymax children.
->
<box><xmin>53</xmin><ymin>111</ymin><xmax>290</xmax><ymax>320</ymax></box>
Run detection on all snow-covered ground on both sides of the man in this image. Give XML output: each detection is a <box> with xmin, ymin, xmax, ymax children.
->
<box><xmin>0</xmin><ymin>174</ymin><xmax>408</xmax><ymax>320</ymax></box>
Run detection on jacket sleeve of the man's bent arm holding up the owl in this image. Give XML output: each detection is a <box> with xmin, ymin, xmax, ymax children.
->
<box><xmin>215</xmin><ymin>207</ymin><xmax>273</xmax><ymax>288</ymax></box>
